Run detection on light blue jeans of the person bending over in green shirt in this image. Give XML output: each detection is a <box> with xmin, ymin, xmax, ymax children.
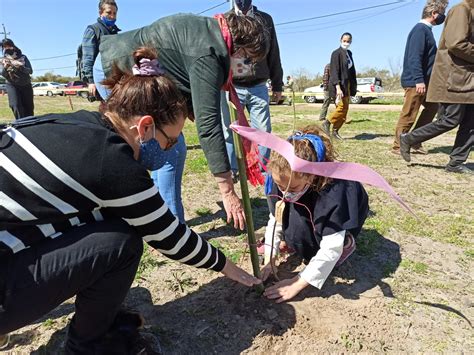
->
<box><xmin>93</xmin><ymin>54</ymin><xmax>187</xmax><ymax>223</ymax></box>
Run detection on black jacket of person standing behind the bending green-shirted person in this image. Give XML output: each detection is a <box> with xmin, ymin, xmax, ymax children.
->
<box><xmin>231</xmin><ymin>6</ymin><xmax>283</xmax><ymax>92</ymax></box>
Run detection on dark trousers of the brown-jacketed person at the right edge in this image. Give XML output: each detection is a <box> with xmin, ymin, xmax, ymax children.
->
<box><xmin>406</xmin><ymin>104</ymin><xmax>474</xmax><ymax>167</ymax></box>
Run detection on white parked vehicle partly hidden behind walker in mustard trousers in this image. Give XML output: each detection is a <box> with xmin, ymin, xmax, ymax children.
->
<box><xmin>303</xmin><ymin>77</ymin><xmax>383</xmax><ymax>104</ymax></box>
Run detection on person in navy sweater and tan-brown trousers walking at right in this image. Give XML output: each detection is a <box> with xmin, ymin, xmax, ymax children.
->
<box><xmin>391</xmin><ymin>0</ymin><xmax>448</xmax><ymax>155</ymax></box>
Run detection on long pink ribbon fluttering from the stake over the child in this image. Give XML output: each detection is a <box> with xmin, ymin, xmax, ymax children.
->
<box><xmin>230</xmin><ymin>124</ymin><xmax>416</xmax><ymax>217</ymax></box>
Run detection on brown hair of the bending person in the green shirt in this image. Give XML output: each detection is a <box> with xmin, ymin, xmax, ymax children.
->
<box><xmin>224</xmin><ymin>12</ymin><xmax>270</xmax><ymax>62</ymax></box>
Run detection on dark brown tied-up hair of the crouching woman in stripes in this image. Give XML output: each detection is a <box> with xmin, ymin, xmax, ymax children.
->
<box><xmin>100</xmin><ymin>47</ymin><xmax>187</xmax><ymax>127</ymax></box>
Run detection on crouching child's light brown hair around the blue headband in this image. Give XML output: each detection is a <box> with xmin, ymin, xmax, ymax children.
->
<box><xmin>268</xmin><ymin>125</ymin><xmax>336</xmax><ymax>192</ymax></box>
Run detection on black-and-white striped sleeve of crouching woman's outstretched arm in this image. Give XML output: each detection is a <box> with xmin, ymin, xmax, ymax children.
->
<box><xmin>98</xmin><ymin>140</ymin><xmax>226</xmax><ymax>271</ymax></box>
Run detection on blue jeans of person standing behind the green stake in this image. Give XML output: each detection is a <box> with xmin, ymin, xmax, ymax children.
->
<box><xmin>221</xmin><ymin>83</ymin><xmax>272</xmax><ymax>171</ymax></box>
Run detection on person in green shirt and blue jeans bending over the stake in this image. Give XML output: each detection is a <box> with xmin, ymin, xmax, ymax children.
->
<box><xmin>94</xmin><ymin>14</ymin><xmax>267</xmax><ymax>229</ymax></box>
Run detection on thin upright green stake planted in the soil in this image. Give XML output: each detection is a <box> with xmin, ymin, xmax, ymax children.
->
<box><xmin>229</xmin><ymin>101</ymin><xmax>264</xmax><ymax>293</ymax></box>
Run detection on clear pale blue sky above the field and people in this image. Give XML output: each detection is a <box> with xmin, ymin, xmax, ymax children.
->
<box><xmin>0</xmin><ymin>0</ymin><xmax>460</xmax><ymax>76</ymax></box>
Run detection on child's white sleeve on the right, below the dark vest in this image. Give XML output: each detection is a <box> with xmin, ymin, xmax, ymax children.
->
<box><xmin>300</xmin><ymin>230</ymin><xmax>346</xmax><ymax>289</ymax></box>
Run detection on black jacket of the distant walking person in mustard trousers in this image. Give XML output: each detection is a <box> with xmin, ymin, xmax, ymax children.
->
<box><xmin>329</xmin><ymin>48</ymin><xmax>357</xmax><ymax>98</ymax></box>
